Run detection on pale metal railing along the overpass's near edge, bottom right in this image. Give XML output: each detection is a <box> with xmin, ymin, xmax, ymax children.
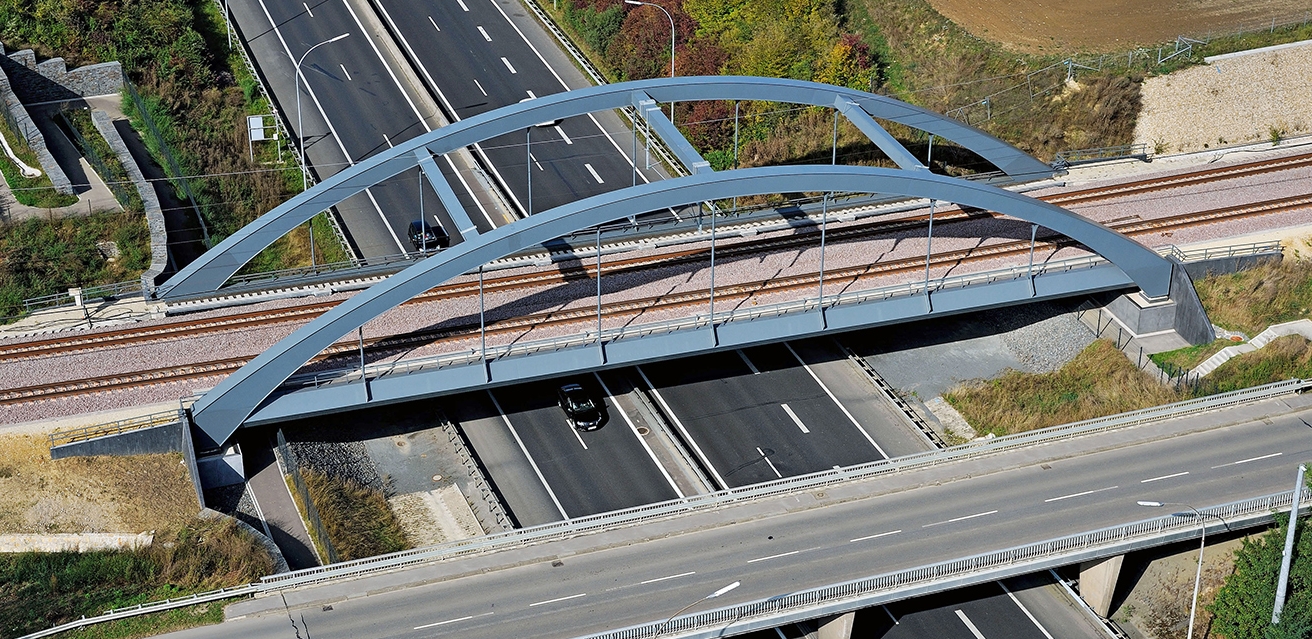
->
<box><xmin>588</xmin><ymin>488</ymin><xmax>1312</xmax><ymax>639</ymax></box>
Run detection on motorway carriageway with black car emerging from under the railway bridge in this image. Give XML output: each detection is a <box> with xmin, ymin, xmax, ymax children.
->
<box><xmin>480</xmin><ymin>375</ymin><xmax>680</xmax><ymax>517</ymax></box>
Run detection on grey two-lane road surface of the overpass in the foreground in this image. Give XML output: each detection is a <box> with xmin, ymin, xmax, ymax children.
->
<box><xmin>169</xmin><ymin>400</ymin><xmax>1312</xmax><ymax>639</ymax></box>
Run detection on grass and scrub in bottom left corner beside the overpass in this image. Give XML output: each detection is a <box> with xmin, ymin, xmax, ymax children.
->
<box><xmin>0</xmin><ymin>520</ymin><xmax>273</xmax><ymax>636</ymax></box>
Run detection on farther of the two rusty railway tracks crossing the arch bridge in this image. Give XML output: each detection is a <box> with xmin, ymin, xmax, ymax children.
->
<box><xmin>10</xmin><ymin>154</ymin><xmax>1312</xmax><ymax>362</ymax></box>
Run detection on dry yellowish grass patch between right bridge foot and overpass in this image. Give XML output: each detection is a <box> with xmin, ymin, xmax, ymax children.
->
<box><xmin>943</xmin><ymin>340</ymin><xmax>1186</xmax><ymax>436</ymax></box>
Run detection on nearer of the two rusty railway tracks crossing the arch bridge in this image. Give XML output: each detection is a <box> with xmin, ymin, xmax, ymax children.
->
<box><xmin>0</xmin><ymin>196</ymin><xmax>1312</xmax><ymax>405</ymax></box>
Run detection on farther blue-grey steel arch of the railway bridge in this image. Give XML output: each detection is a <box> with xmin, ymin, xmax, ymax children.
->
<box><xmin>157</xmin><ymin>76</ymin><xmax>1052</xmax><ymax>298</ymax></box>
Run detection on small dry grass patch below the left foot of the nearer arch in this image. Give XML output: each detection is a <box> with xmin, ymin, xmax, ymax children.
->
<box><xmin>293</xmin><ymin>468</ymin><xmax>411</xmax><ymax>562</ymax></box>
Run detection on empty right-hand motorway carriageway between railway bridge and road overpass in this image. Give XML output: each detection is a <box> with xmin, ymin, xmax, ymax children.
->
<box><xmin>639</xmin><ymin>344</ymin><xmax>902</xmax><ymax>487</ymax></box>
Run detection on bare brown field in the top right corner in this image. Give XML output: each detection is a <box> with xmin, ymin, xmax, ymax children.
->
<box><xmin>929</xmin><ymin>0</ymin><xmax>1308</xmax><ymax>54</ymax></box>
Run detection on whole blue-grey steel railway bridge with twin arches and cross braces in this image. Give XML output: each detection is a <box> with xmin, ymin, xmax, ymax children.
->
<box><xmin>169</xmin><ymin>76</ymin><xmax>1173</xmax><ymax>447</ymax></box>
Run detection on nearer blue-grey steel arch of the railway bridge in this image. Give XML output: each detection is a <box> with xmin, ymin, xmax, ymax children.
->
<box><xmin>192</xmin><ymin>164</ymin><xmax>1172</xmax><ymax>443</ymax></box>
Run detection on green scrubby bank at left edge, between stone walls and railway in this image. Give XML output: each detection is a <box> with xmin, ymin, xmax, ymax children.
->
<box><xmin>0</xmin><ymin>213</ymin><xmax>151</xmax><ymax>323</ymax></box>
